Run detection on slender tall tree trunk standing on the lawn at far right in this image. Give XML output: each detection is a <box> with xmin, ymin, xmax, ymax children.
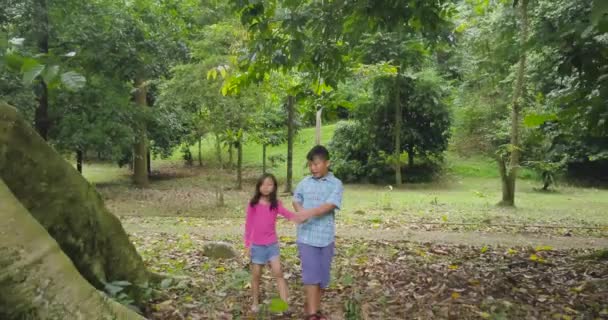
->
<box><xmin>500</xmin><ymin>0</ymin><xmax>528</xmax><ymax>206</ymax></box>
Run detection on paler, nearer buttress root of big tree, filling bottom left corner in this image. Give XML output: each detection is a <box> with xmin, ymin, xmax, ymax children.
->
<box><xmin>0</xmin><ymin>179</ymin><xmax>143</xmax><ymax>320</ymax></box>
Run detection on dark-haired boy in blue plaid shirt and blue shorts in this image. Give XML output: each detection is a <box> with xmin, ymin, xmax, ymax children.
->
<box><xmin>293</xmin><ymin>146</ymin><xmax>344</xmax><ymax>320</ymax></box>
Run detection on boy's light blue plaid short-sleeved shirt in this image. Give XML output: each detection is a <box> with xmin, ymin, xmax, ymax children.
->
<box><xmin>293</xmin><ymin>172</ymin><xmax>344</xmax><ymax>247</ymax></box>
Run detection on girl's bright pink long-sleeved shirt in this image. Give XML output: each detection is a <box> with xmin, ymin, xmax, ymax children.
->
<box><xmin>245</xmin><ymin>201</ymin><xmax>295</xmax><ymax>248</ymax></box>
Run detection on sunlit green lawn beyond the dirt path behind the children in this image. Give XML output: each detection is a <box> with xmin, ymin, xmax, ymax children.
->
<box><xmin>79</xmin><ymin>125</ymin><xmax>608</xmax><ymax>234</ymax></box>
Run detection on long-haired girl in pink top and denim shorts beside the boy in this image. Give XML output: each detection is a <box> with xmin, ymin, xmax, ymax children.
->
<box><xmin>245</xmin><ymin>173</ymin><xmax>301</xmax><ymax>312</ymax></box>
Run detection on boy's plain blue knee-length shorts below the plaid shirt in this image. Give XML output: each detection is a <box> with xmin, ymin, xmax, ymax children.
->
<box><xmin>298</xmin><ymin>242</ymin><xmax>334</xmax><ymax>289</ymax></box>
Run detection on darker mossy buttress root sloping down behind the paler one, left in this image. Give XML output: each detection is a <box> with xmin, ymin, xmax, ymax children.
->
<box><xmin>0</xmin><ymin>104</ymin><xmax>151</xmax><ymax>300</ymax></box>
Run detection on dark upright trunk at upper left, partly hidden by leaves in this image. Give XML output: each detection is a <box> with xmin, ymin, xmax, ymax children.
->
<box><xmin>33</xmin><ymin>0</ymin><xmax>51</xmax><ymax>140</ymax></box>
